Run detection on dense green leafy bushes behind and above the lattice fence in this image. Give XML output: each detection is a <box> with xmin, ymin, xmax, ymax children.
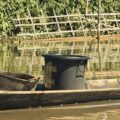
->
<box><xmin>0</xmin><ymin>0</ymin><xmax>120</xmax><ymax>37</ymax></box>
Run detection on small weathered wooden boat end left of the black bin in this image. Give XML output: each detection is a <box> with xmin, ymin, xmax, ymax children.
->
<box><xmin>0</xmin><ymin>72</ymin><xmax>38</xmax><ymax>91</ymax></box>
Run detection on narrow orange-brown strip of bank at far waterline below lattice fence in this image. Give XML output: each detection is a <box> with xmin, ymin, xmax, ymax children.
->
<box><xmin>10</xmin><ymin>34</ymin><xmax>120</xmax><ymax>44</ymax></box>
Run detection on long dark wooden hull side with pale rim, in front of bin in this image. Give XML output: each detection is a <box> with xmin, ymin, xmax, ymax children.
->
<box><xmin>0</xmin><ymin>88</ymin><xmax>120</xmax><ymax>110</ymax></box>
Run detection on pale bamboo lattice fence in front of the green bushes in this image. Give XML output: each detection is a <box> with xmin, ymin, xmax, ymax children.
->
<box><xmin>14</xmin><ymin>9</ymin><xmax>120</xmax><ymax>39</ymax></box>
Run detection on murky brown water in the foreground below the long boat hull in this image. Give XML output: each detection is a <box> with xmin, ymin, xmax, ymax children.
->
<box><xmin>0</xmin><ymin>100</ymin><xmax>120</xmax><ymax>120</ymax></box>
